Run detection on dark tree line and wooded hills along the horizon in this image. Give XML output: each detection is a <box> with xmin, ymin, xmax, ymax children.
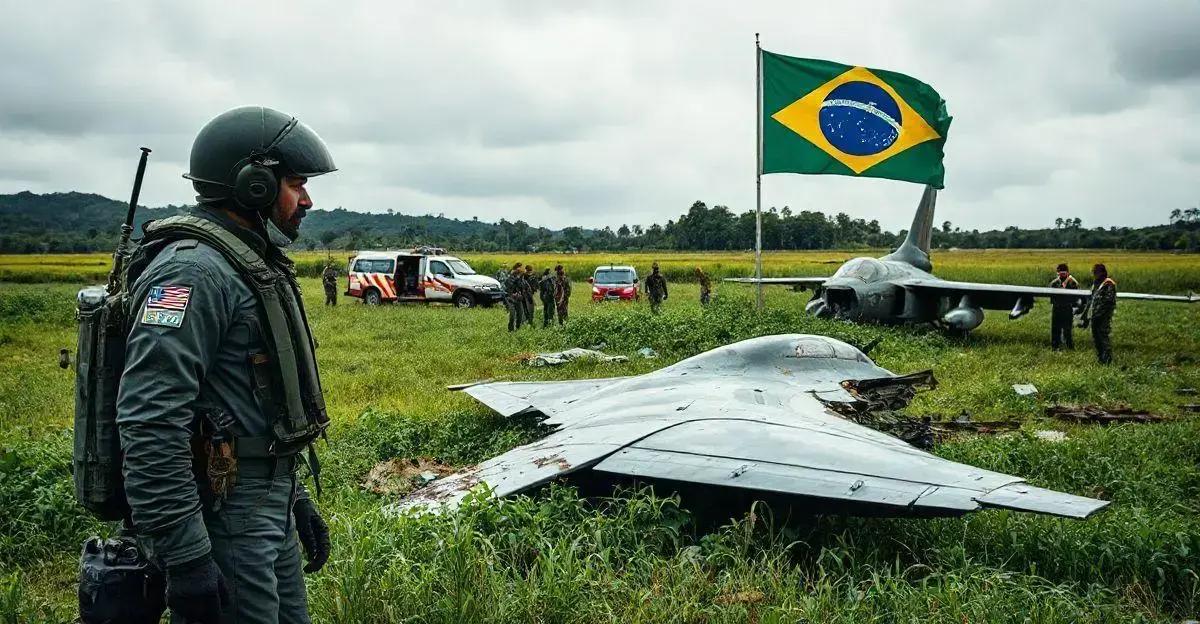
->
<box><xmin>0</xmin><ymin>192</ymin><xmax>1200</xmax><ymax>253</ymax></box>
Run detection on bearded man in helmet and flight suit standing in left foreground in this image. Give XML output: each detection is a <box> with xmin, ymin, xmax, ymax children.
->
<box><xmin>116</xmin><ymin>107</ymin><xmax>335</xmax><ymax>624</ymax></box>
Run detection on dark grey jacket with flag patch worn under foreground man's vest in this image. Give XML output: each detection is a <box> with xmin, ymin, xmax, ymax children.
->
<box><xmin>116</xmin><ymin>211</ymin><xmax>302</xmax><ymax>565</ymax></box>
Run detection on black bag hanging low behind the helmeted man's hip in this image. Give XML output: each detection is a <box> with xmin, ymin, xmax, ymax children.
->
<box><xmin>79</xmin><ymin>535</ymin><xmax>167</xmax><ymax>624</ymax></box>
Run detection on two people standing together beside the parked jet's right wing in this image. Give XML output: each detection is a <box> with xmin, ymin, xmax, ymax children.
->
<box><xmin>1050</xmin><ymin>263</ymin><xmax>1117</xmax><ymax>364</ymax></box>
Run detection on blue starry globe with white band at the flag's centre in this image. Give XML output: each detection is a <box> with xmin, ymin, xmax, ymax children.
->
<box><xmin>820</xmin><ymin>80</ymin><xmax>901</xmax><ymax>156</ymax></box>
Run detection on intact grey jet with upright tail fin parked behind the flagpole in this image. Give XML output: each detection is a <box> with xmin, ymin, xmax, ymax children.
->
<box><xmin>726</xmin><ymin>186</ymin><xmax>1200</xmax><ymax>334</ymax></box>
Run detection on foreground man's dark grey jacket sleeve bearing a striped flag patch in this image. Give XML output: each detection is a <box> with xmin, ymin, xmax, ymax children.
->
<box><xmin>116</xmin><ymin>248</ymin><xmax>234</xmax><ymax>565</ymax></box>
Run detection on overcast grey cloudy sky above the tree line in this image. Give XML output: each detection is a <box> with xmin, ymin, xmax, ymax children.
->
<box><xmin>0</xmin><ymin>0</ymin><xmax>1200</xmax><ymax>229</ymax></box>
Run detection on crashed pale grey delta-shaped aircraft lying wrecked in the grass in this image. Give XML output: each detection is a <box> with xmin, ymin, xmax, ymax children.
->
<box><xmin>398</xmin><ymin>334</ymin><xmax>1108</xmax><ymax>518</ymax></box>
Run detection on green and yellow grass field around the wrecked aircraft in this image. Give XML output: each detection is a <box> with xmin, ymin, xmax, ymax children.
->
<box><xmin>0</xmin><ymin>251</ymin><xmax>1200</xmax><ymax>623</ymax></box>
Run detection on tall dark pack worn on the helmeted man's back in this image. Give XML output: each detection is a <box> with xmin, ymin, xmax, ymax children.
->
<box><xmin>72</xmin><ymin>287</ymin><xmax>128</xmax><ymax>521</ymax></box>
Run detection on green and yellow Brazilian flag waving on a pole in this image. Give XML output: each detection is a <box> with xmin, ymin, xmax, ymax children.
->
<box><xmin>761</xmin><ymin>50</ymin><xmax>950</xmax><ymax>188</ymax></box>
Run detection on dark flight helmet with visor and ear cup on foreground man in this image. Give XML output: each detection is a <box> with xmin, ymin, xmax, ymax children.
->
<box><xmin>184</xmin><ymin>106</ymin><xmax>337</xmax><ymax>210</ymax></box>
